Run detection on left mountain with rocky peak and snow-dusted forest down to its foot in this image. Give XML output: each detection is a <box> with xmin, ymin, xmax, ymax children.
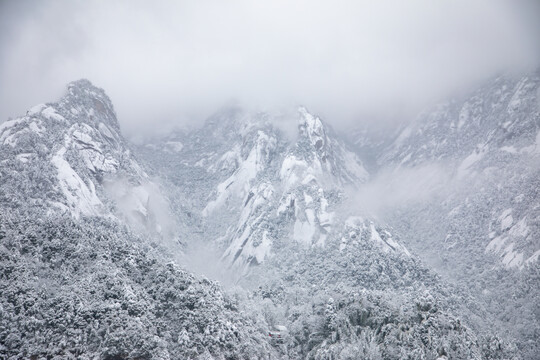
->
<box><xmin>0</xmin><ymin>80</ymin><xmax>275</xmax><ymax>359</ymax></box>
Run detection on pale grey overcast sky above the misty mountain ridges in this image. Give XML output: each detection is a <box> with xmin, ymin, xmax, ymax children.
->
<box><xmin>0</xmin><ymin>0</ymin><xmax>540</xmax><ymax>135</ymax></box>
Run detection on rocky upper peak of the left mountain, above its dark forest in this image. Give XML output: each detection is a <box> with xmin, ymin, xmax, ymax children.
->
<box><xmin>0</xmin><ymin>80</ymin><xmax>174</xmax><ymax>240</ymax></box>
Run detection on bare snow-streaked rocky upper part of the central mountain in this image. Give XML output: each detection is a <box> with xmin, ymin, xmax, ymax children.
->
<box><xmin>144</xmin><ymin>107</ymin><xmax>382</xmax><ymax>270</ymax></box>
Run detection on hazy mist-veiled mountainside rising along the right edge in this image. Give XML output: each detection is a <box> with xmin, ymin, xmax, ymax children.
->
<box><xmin>353</xmin><ymin>72</ymin><xmax>540</xmax><ymax>359</ymax></box>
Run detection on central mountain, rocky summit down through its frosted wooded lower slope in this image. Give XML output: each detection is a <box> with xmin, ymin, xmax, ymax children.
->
<box><xmin>140</xmin><ymin>102</ymin><xmax>511</xmax><ymax>359</ymax></box>
